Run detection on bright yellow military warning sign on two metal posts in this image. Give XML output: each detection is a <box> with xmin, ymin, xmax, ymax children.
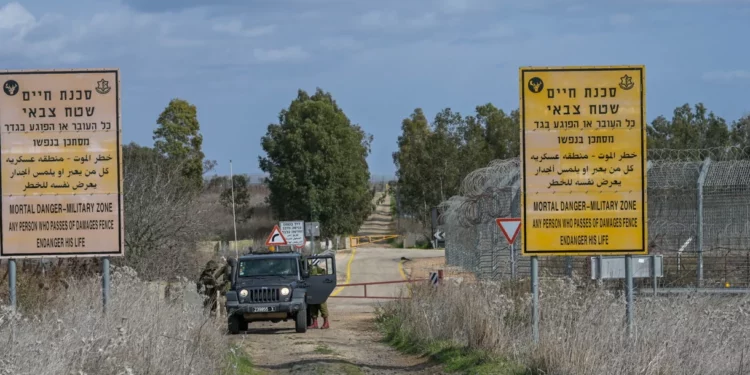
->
<box><xmin>519</xmin><ymin>65</ymin><xmax>648</xmax><ymax>342</ymax></box>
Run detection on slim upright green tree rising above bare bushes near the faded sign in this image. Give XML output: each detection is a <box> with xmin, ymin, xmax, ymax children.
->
<box><xmin>153</xmin><ymin>99</ymin><xmax>206</xmax><ymax>188</ymax></box>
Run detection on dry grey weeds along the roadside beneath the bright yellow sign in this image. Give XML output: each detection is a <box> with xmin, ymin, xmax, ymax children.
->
<box><xmin>384</xmin><ymin>279</ymin><xmax>750</xmax><ymax>375</ymax></box>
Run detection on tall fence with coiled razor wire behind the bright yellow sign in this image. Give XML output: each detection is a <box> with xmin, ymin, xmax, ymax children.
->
<box><xmin>439</xmin><ymin>147</ymin><xmax>750</xmax><ymax>287</ymax></box>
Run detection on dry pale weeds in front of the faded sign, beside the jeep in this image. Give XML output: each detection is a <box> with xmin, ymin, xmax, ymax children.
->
<box><xmin>0</xmin><ymin>269</ymin><xmax>227</xmax><ymax>375</ymax></box>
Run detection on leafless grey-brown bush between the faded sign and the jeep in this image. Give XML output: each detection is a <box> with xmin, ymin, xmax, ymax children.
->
<box><xmin>122</xmin><ymin>143</ymin><xmax>215</xmax><ymax>279</ymax></box>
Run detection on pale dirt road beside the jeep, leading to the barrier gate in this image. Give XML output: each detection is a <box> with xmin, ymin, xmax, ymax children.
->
<box><xmin>232</xmin><ymin>247</ymin><xmax>443</xmax><ymax>375</ymax></box>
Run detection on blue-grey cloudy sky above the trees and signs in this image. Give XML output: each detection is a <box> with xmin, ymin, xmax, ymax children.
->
<box><xmin>0</xmin><ymin>0</ymin><xmax>750</xmax><ymax>175</ymax></box>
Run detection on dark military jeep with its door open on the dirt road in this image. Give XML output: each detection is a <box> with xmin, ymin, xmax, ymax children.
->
<box><xmin>225</xmin><ymin>251</ymin><xmax>336</xmax><ymax>334</ymax></box>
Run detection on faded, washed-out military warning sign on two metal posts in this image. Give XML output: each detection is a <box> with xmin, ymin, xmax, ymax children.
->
<box><xmin>0</xmin><ymin>69</ymin><xmax>124</xmax><ymax>311</ymax></box>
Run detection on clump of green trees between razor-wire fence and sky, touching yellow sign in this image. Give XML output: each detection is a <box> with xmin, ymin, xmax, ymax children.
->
<box><xmin>393</xmin><ymin>103</ymin><xmax>520</xmax><ymax>229</ymax></box>
